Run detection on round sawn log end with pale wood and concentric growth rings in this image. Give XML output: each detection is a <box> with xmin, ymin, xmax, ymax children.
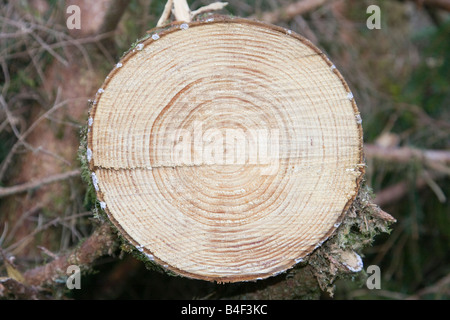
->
<box><xmin>87</xmin><ymin>18</ymin><xmax>364</xmax><ymax>282</ymax></box>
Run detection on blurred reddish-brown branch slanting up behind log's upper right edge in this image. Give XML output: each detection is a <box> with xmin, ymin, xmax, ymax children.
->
<box><xmin>250</xmin><ymin>0</ymin><xmax>330</xmax><ymax>23</ymax></box>
